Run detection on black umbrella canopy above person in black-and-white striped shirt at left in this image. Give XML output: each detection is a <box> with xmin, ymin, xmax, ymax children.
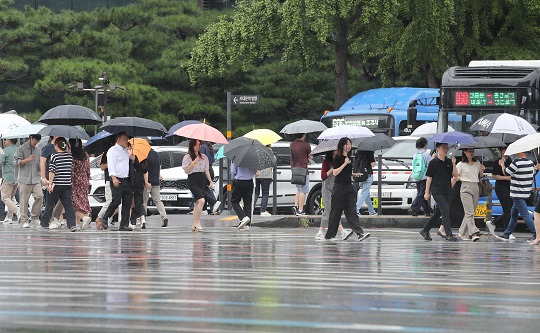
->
<box><xmin>39</xmin><ymin>105</ymin><xmax>101</xmax><ymax>125</ymax></box>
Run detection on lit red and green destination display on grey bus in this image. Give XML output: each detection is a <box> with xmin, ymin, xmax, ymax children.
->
<box><xmin>454</xmin><ymin>91</ymin><xmax>517</xmax><ymax>107</ymax></box>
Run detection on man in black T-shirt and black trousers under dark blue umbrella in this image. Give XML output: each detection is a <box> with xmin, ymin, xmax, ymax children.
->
<box><xmin>420</xmin><ymin>143</ymin><xmax>457</xmax><ymax>242</ymax></box>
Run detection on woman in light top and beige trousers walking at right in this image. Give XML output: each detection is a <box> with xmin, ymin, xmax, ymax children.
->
<box><xmin>456</xmin><ymin>148</ymin><xmax>486</xmax><ymax>242</ymax></box>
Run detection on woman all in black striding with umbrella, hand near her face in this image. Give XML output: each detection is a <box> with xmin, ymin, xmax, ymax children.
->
<box><xmin>324</xmin><ymin>137</ymin><xmax>370</xmax><ymax>242</ymax></box>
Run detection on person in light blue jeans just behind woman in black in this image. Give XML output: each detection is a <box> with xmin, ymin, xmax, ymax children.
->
<box><xmin>353</xmin><ymin>150</ymin><xmax>377</xmax><ymax>216</ymax></box>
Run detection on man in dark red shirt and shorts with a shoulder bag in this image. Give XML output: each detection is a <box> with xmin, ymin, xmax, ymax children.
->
<box><xmin>291</xmin><ymin>134</ymin><xmax>312</xmax><ymax>215</ymax></box>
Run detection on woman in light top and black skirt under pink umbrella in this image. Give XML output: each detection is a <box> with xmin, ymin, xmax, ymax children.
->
<box><xmin>182</xmin><ymin>139</ymin><xmax>214</xmax><ymax>231</ymax></box>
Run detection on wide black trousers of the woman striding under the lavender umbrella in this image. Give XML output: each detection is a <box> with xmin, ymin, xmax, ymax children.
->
<box><xmin>324</xmin><ymin>183</ymin><xmax>364</xmax><ymax>239</ymax></box>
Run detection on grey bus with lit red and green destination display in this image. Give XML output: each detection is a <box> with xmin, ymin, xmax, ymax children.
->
<box><xmin>437</xmin><ymin>60</ymin><xmax>540</xmax><ymax>224</ymax></box>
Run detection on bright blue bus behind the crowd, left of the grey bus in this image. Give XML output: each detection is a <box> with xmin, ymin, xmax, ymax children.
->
<box><xmin>321</xmin><ymin>87</ymin><xmax>470</xmax><ymax>137</ymax></box>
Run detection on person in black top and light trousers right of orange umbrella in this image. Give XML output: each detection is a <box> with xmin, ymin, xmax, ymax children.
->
<box><xmin>143</xmin><ymin>149</ymin><xmax>169</xmax><ymax>227</ymax></box>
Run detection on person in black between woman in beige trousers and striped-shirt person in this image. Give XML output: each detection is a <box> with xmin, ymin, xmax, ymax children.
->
<box><xmin>486</xmin><ymin>148</ymin><xmax>513</xmax><ymax>235</ymax></box>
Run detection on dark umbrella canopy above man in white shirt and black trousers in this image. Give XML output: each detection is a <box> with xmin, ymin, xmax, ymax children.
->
<box><xmin>100</xmin><ymin>117</ymin><xmax>167</xmax><ymax>137</ymax></box>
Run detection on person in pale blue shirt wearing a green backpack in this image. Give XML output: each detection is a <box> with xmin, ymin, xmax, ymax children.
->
<box><xmin>409</xmin><ymin>137</ymin><xmax>432</xmax><ymax>216</ymax></box>
